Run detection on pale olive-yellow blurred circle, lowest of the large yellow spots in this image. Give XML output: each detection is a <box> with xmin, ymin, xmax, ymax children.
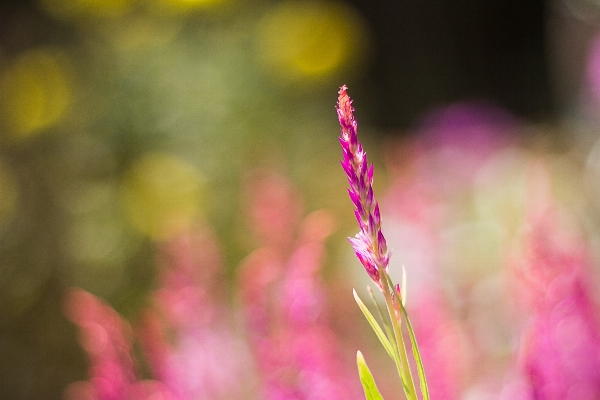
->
<box><xmin>121</xmin><ymin>153</ymin><xmax>201</xmax><ymax>240</ymax></box>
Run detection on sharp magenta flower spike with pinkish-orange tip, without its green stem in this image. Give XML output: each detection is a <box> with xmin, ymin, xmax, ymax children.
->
<box><xmin>337</xmin><ymin>86</ymin><xmax>390</xmax><ymax>286</ymax></box>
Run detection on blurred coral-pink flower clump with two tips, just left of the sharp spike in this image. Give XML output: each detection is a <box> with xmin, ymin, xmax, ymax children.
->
<box><xmin>240</xmin><ymin>172</ymin><xmax>360</xmax><ymax>400</ymax></box>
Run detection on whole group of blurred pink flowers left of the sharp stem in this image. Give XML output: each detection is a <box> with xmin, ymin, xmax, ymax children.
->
<box><xmin>65</xmin><ymin>171</ymin><xmax>361</xmax><ymax>400</ymax></box>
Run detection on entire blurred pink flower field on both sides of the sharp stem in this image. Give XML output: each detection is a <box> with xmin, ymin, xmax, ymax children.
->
<box><xmin>65</xmin><ymin>94</ymin><xmax>600</xmax><ymax>399</ymax></box>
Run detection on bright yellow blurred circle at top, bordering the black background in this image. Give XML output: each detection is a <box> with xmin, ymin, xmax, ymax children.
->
<box><xmin>256</xmin><ymin>1</ymin><xmax>366</xmax><ymax>80</ymax></box>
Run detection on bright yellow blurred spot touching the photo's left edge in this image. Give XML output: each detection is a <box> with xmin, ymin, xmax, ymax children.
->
<box><xmin>0</xmin><ymin>49</ymin><xmax>72</xmax><ymax>137</ymax></box>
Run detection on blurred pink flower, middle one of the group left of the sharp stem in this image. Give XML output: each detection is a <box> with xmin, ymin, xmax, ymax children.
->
<box><xmin>139</xmin><ymin>226</ymin><xmax>251</xmax><ymax>400</ymax></box>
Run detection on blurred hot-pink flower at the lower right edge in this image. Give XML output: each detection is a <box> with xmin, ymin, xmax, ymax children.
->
<box><xmin>511</xmin><ymin>210</ymin><xmax>600</xmax><ymax>400</ymax></box>
